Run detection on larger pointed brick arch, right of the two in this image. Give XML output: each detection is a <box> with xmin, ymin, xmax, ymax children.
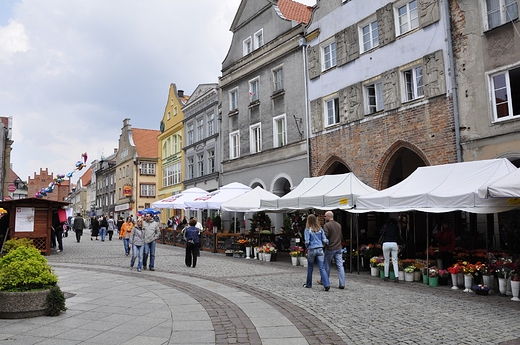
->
<box><xmin>374</xmin><ymin>140</ymin><xmax>431</xmax><ymax>190</ymax></box>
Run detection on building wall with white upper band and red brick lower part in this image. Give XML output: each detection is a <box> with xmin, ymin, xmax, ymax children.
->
<box><xmin>307</xmin><ymin>0</ymin><xmax>457</xmax><ymax>188</ymax></box>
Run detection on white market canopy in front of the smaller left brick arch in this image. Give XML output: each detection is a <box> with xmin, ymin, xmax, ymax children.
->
<box><xmin>260</xmin><ymin>173</ymin><xmax>377</xmax><ymax>211</ymax></box>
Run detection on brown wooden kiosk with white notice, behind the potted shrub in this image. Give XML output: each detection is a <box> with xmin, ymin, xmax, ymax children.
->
<box><xmin>0</xmin><ymin>198</ymin><xmax>69</xmax><ymax>255</ymax></box>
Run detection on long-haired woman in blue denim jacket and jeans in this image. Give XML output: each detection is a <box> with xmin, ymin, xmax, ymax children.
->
<box><xmin>303</xmin><ymin>214</ymin><xmax>330</xmax><ymax>291</ymax></box>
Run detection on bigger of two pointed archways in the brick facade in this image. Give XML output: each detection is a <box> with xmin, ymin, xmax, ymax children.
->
<box><xmin>374</xmin><ymin>140</ymin><xmax>431</xmax><ymax>190</ymax></box>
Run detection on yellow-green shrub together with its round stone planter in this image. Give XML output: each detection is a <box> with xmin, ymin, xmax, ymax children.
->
<box><xmin>0</xmin><ymin>239</ymin><xmax>67</xmax><ymax>318</ymax></box>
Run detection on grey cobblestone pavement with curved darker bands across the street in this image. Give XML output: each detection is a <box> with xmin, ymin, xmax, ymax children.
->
<box><xmin>0</xmin><ymin>234</ymin><xmax>520</xmax><ymax>345</ymax></box>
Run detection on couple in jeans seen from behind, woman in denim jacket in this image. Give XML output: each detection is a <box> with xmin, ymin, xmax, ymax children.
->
<box><xmin>303</xmin><ymin>211</ymin><xmax>345</xmax><ymax>291</ymax></box>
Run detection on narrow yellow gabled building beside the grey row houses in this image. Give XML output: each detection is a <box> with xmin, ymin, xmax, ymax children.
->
<box><xmin>157</xmin><ymin>84</ymin><xmax>189</xmax><ymax>223</ymax></box>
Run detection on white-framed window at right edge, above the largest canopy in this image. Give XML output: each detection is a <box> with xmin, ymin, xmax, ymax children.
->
<box><xmin>491</xmin><ymin>67</ymin><xmax>520</xmax><ymax>120</ymax></box>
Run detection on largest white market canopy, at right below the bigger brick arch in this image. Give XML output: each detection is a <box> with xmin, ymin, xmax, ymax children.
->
<box><xmin>355</xmin><ymin>158</ymin><xmax>519</xmax><ymax>213</ymax></box>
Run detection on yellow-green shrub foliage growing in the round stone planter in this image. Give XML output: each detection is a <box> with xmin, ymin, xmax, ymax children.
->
<box><xmin>0</xmin><ymin>247</ymin><xmax>58</xmax><ymax>291</ymax></box>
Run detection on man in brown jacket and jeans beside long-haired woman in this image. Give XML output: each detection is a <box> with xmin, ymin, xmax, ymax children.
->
<box><xmin>318</xmin><ymin>211</ymin><xmax>345</xmax><ymax>289</ymax></box>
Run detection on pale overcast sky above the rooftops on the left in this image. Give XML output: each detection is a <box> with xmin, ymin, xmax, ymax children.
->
<box><xmin>0</xmin><ymin>0</ymin><xmax>315</xmax><ymax>183</ymax></box>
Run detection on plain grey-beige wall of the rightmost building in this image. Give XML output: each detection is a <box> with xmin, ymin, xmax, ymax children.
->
<box><xmin>450</xmin><ymin>0</ymin><xmax>520</xmax><ymax>161</ymax></box>
